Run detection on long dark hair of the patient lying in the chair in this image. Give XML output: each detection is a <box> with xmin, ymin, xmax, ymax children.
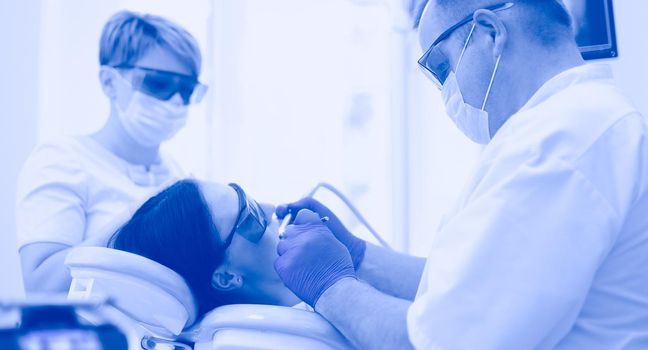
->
<box><xmin>108</xmin><ymin>180</ymin><xmax>231</xmax><ymax>318</ymax></box>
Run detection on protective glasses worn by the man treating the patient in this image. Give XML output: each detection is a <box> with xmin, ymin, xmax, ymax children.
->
<box><xmin>418</xmin><ymin>2</ymin><xmax>513</xmax><ymax>89</ymax></box>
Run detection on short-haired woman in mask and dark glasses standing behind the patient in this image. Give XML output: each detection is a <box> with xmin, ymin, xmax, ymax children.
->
<box><xmin>16</xmin><ymin>11</ymin><xmax>205</xmax><ymax>293</ymax></box>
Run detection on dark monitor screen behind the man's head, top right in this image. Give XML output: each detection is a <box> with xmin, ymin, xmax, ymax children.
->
<box><xmin>563</xmin><ymin>0</ymin><xmax>619</xmax><ymax>60</ymax></box>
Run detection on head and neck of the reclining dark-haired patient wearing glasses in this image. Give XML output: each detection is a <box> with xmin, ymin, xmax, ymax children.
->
<box><xmin>109</xmin><ymin>180</ymin><xmax>300</xmax><ymax>319</ymax></box>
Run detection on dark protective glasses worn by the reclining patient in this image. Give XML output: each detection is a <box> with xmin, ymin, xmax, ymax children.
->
<box><xmin>225</xmin><ymin>183</ymin><xmax>268</xmax><ymax>246</ymax></box>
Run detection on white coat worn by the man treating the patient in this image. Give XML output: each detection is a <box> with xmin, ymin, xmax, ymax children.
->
<box><xmin>408</xmin><ymin>64</ymin><xmax>648</xmax><ymax>350</ymax></box>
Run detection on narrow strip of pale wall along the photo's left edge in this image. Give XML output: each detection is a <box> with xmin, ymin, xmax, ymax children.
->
<box><xmin>0</xmin><ymin>1</ymin><xmax>40</xmax><ymax>299</ymax></box>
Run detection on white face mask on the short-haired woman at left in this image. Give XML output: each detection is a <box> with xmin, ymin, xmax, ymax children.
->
<box><xmin>110</xmin><ymin>72</ymin><xmax>187</xmax><ymax>147</ymax></box>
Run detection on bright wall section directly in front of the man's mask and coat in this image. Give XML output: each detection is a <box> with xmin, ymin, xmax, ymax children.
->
<box><xmin>408</xmin><ymin>34</ymin><xmax>481</xmax><ymax>256</ymax></box>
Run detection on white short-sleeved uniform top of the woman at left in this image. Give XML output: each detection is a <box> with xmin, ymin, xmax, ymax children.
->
<box><xmin>16</xmin><ymin>136</ymin><xmax>183</xmax><ymax>249</ymax></box>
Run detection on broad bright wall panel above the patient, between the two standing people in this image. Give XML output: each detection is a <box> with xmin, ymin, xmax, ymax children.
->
<box><xmin>210</xmin><ymin>0</ymin><xmax>400</xmax><ymax>246</ymax></box>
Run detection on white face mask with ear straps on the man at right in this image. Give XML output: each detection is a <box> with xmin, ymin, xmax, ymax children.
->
<box><xmin>441</xmin><ymin>24</ymin><xmax>502</xmax><ymax>144</ymax></box>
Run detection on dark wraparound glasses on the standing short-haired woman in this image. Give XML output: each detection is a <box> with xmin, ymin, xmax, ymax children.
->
<box><xmin>114</xmin><ymin>65</ymin><xmax>207</xmax><ymax>105</ymax></box>
